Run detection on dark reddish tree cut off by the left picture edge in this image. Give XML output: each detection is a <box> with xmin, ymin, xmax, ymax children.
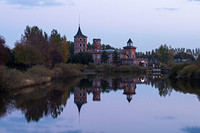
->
<box><xmin>0</xmin><ymin>36</ymin><xmax>11</xmax><ymax>65</ymax></box>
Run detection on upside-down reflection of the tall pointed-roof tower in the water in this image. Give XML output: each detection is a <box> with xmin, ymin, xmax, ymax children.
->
<box><xmin>74</xmin><ymin>87</ymin><xmax>87</xmax><ymax>112</ymax></box>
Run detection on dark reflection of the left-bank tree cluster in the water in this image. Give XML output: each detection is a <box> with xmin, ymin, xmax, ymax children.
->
<box><xmin>12</xmin><ymin>80</ymin><xmax>77</xmax><ymax>122</ymax></box>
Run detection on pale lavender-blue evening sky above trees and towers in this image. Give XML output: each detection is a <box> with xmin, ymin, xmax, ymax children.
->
<box><xmin>0</xmin><ymin>0</ymin><xmax>200</xmax><ymax>52</ymax></box>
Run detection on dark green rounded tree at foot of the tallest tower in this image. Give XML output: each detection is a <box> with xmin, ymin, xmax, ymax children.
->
<box><xmin>72</xmin><ymin>52</ymin><xmax>94</xmax><ymax>65</ymax></box>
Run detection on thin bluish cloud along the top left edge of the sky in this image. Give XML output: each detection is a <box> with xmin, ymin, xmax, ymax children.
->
<box><xmin>0</xmin><ymin>0</ymin><xmax>73</xmax><ymax>7</ymax></box>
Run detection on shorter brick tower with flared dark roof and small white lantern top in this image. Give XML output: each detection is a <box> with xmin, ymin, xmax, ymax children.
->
<box><xmin>124</xmin><ymin>39</ymin><xmax>136</xmax><ymax>58</ymax></box>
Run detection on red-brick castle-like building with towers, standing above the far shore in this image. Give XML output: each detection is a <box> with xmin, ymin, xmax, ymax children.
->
<box><xmin>74</xmin><ymin>26</ymin><xmax>148</xmax><ymax>67</ymax></box>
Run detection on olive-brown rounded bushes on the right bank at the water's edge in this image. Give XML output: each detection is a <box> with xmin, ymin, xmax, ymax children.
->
<box><xmin>169</xmin><ymin>63</ymin><xmax>200</xmax><ymax>80</ymax></box>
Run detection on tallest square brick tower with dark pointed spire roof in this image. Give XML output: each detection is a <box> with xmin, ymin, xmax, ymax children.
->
<box><xmin>74</xmin><ymin>25</ymin><xmax>87</xmax><ymax>54</ymax></box>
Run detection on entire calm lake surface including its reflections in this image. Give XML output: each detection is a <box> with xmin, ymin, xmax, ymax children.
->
<box><xmin>0</xmin><ymin>75</ymin><xmax>200</xmax><ymax>133</ymax></box>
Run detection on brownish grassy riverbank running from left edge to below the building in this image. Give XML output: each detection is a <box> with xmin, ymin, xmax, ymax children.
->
<box><xmin>0</xmin><ymin>63</ymin><xmax>146</xmax><ymax>89</ymax></box>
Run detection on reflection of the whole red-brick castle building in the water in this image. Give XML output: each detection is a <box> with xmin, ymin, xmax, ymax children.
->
<box><xmin>74</xmin><ymin>77</ymin><xmax>147</xmax><ymax>112</ymax></box>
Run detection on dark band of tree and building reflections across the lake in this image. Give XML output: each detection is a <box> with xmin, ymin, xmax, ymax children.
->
<box><xmin>0</xmin><ymin>75</ymin><xmax>200</xmax><ymax>122</ymax></box>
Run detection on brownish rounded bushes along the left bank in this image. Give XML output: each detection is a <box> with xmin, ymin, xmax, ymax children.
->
<box><xmin>0</xmin><ymin>63</ymin><xmax>83</xmax><ymax>89</ymax></box>
